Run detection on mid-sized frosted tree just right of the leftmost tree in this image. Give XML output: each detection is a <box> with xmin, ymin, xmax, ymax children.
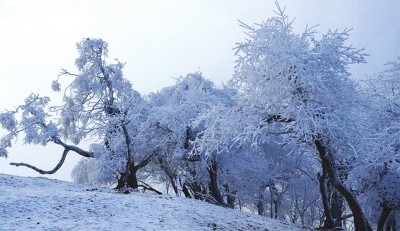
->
<box><xmin>141</xmin><ymin>72</ymin><xmax>235</xmax><ymax>203</ymax></box>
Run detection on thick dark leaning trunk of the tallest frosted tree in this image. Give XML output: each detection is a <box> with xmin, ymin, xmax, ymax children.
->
<box><xmin>314</xmin><ymin>140</ymin><xmax>372</xmax><ymax>231</ymax></box>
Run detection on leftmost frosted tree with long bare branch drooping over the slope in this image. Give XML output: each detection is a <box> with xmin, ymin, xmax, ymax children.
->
<box><xmin>0</xmin><ymin>38</ymin><xmax>151</xmax><ymax>188</ymax></box>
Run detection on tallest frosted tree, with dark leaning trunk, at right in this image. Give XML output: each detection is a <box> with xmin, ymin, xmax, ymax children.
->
<box><xmin>225</xmin><ymin>4</ymin><xmax>371</xmax><ymax>230</ymax></box>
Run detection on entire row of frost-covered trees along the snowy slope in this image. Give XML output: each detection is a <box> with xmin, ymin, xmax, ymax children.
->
<box><xmin>0</xmin><ymin>4</ymin><xmax>400</xmax><ymax>231</ymax></box>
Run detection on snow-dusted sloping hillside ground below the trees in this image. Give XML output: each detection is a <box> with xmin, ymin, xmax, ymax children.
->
<box><xmin>0</xmin><ymin>174</ymin><xmax>301</xmax><ymax>231</ymax></box>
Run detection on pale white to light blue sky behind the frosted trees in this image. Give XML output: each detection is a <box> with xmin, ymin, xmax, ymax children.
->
<box><xmin>0</xmin><ymin>0</ymin><xmax>400</xmax><ymax>180</ymax></box>
